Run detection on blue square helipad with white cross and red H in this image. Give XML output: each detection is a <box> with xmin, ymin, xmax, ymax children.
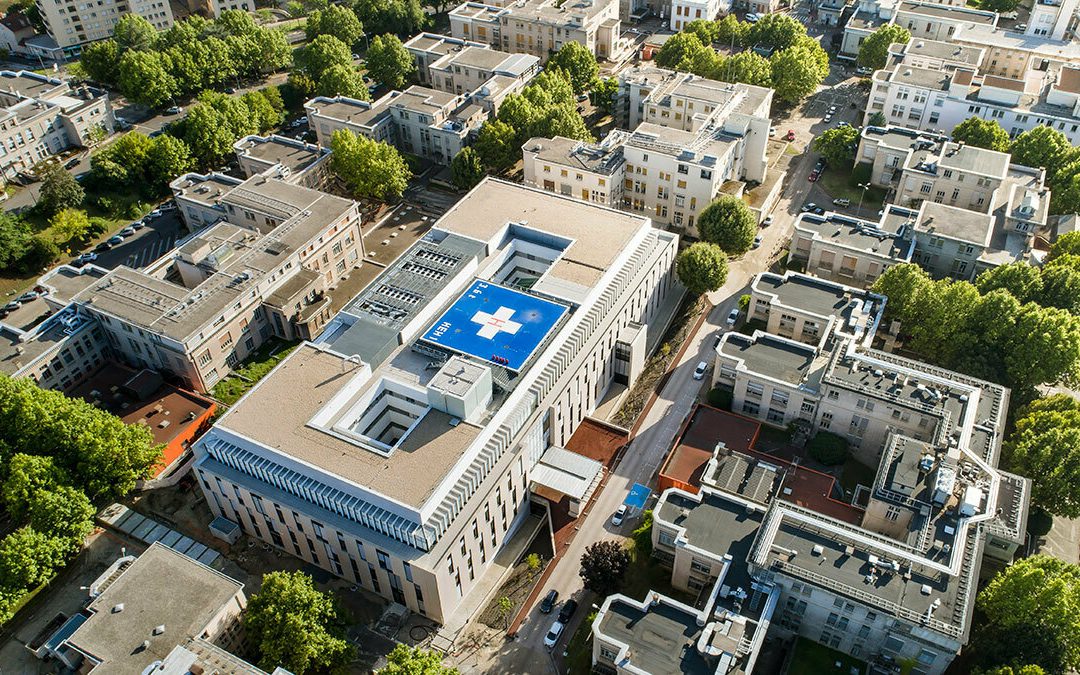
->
<box><xmin>421</xmin><ymin>280</ymin><xmax>567</xmax><ymax>370</ymax></box>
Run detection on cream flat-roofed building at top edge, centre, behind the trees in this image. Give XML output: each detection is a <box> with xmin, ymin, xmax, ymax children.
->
<box><xmin>449</xmin><ymin>0</ymin><xmax>632</xmax><ymax>60</ymax></box>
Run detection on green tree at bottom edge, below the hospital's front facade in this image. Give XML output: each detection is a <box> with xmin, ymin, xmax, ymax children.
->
<box><xmin>243</xmin><ymin>571</ymin><xmax>353</xmax><ymax>675</ymax></box>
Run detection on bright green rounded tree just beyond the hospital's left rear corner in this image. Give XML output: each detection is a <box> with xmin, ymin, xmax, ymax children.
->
<box><xmin>330</xmin><ymin>129</ymin><xmax>413</xmax><ymax>201</ymax></box>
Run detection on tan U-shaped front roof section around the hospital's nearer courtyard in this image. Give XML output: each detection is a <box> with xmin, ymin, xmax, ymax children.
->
<box><xmin>218</xmin><ymin>343</ymin><xmax>481</xmax><ymax>508</ymax></box>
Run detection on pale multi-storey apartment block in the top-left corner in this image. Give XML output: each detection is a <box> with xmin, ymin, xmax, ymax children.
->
<box><xmin>37</xmin><ymin>0</ymin><xmax>174</xmax><ymax>56</ymax></box>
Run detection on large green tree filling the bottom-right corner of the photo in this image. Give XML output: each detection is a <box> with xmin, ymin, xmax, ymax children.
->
<box><xmin>976</xmin><ymin>555</ymin><xmax>1080</xmax><ymax>673</ymax></box>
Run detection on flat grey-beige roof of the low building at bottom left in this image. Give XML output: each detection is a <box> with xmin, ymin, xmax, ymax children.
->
<box><xmin>68</xmin><ymin>543</ymin><xmax>244</xmax><ymax>675</ymax></box>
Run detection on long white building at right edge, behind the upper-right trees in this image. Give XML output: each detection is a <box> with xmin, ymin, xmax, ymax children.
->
<box><xmin>864</xmin><ymin>43</ymin><xmax>1080</xmax><ymax>145</ymax></box>
